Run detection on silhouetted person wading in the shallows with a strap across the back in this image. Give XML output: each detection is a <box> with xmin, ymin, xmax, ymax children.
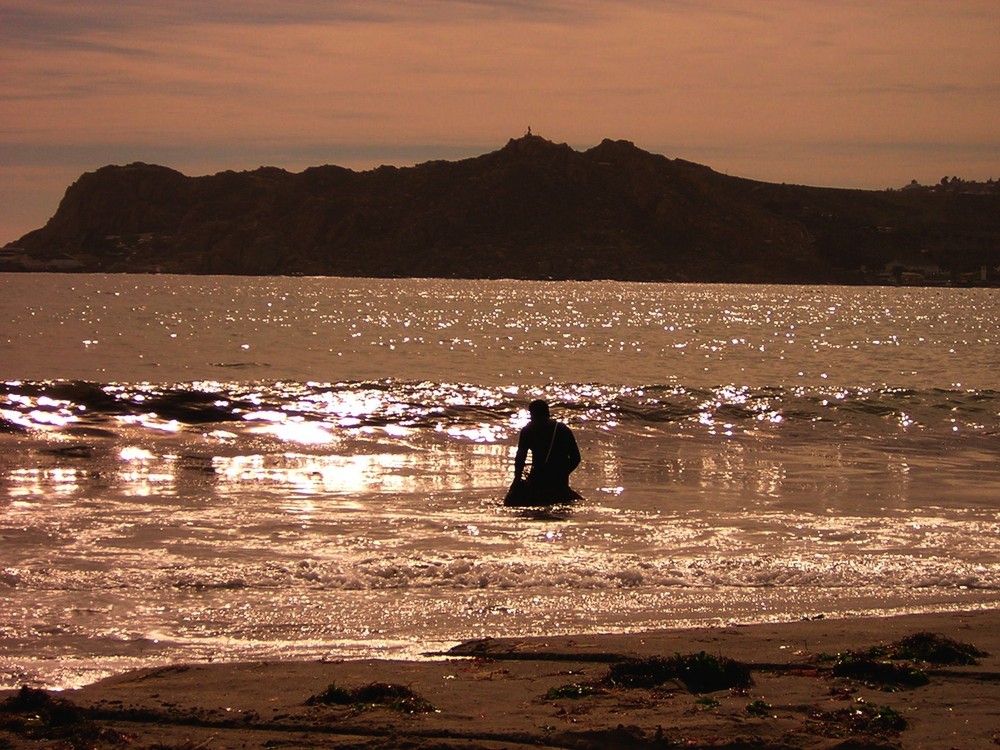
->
<box><xmin>508</xmin><ymin>400</ymin><xmax>580</xmax><ymax>505</ymax></box>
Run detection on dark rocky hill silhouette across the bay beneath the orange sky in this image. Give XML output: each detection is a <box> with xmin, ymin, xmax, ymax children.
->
<box><xmin>0</xmin><ymin>135</ymin><xmax>1000</xmax><ymax>283</ymax></box>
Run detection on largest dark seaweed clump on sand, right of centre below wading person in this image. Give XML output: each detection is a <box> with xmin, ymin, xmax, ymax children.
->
<box><xmin>604</xmin><ymin>651</ymin><xmax>753</xmax><ymax>693</ymax></box>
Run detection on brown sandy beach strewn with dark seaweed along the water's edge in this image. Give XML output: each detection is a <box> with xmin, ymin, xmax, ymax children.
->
<box><xmin>0</xmin><ymin>611</ymin><xmax>1000</xmax><ymax>750</ymax></box>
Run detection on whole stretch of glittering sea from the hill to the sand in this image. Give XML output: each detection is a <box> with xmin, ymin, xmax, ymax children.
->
<box><xmin>0</xmin><ymin>274</ymin><xmax>1000</xmax><ymax>688</ymax></box>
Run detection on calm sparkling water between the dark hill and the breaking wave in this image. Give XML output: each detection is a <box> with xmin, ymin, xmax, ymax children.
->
<box><xmin>0</xmin><ymin>274</ymin><xmax>998</xmax><ymax>388</ymax></box>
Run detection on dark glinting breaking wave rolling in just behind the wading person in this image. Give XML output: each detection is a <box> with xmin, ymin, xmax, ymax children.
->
<box><xmin>0</xmin><ymin>380</ymin><xmax>1000</xmax><ymax>436</ymax></box>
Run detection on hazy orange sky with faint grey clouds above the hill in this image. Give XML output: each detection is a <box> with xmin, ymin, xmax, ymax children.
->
<box><xmin>0</xmin><ymin>0</ymin><xmax>1000</xmax><ymax>244</ymax></box>
